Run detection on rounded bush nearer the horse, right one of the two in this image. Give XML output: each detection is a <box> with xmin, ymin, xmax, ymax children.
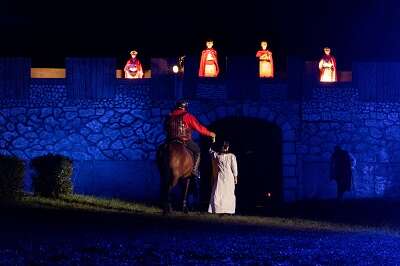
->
<box><xmin>31</xmin><ymin>154</ymin><xmax>73</xmax><ymax>197</ymax></box>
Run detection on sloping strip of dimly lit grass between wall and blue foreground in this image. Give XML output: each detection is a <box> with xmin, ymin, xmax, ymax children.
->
<box><xmin>3</xmin><ymin>194</ymin><xmax>400</xmax><ymax>233</ymax></box>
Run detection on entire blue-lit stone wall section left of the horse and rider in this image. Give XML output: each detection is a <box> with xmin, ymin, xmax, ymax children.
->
<box><xmin>0</xmin><ymin>80</ymin><xmax>168</xmax><ymax>199</ymax></box>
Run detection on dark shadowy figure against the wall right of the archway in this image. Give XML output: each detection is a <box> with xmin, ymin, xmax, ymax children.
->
<box><xmin>330</xmin><ymin>145</ymin><xmax>352</xmax><ymax>200</ymax></box>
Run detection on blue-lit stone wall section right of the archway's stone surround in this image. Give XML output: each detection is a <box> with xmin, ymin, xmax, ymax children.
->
<box><xmin>296</xmin><ymin>87</ymin><xmax>400</xmax><ymax>198</ymax></box>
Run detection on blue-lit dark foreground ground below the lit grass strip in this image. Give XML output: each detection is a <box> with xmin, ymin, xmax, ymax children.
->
<box><xmin>0</xmin><ymin>202</ymin><xmax>400</xmax><ymax>265</ymax></box>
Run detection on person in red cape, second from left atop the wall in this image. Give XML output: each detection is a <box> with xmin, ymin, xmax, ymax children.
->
<box><xmin>199</xmin><ymin>41</ymin><xmax>219</xmax><ymax>78</ymax></box>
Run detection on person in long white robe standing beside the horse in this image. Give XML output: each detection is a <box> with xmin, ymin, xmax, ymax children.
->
<box><xmin>208</xmin><ymin>141</ymin><xmax>238</xmax><ymax>214</ymax></box>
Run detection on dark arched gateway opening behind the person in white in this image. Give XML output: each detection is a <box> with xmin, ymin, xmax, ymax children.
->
<box><xmin>201</xmin><ymin>117</ymin><xmax>283</xmax><ymax>212</ymax></box>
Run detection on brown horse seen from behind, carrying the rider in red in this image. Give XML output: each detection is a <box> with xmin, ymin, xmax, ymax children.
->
<box><xmin>157</xmin><ymin>141</ymin><xmax>194</xmax><ymax>214</ymax></box>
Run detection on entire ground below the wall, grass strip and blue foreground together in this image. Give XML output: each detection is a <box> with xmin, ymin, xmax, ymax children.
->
<box><xmin>0</xmin><ymin>195</ymin><xmax>400</xmax><ymax>265</ymax></box>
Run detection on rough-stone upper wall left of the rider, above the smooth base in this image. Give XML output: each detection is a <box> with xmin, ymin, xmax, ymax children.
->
<box><xmin>0</xmin><ymin>81</ymin><xmax>163</xmax><ymax>160</ymax></box>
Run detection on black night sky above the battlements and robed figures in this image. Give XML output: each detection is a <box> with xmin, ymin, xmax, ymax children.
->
<box><xmin>0</xmin><ymin>0</ymin><xmax>400</xmax><ymax>70</ymax></box>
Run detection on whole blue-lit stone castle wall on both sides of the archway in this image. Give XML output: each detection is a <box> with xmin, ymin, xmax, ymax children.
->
<box><xmin>0</xmin><ymin>79</ymin><xmax>400</xmax><ymax>201</ymax></box>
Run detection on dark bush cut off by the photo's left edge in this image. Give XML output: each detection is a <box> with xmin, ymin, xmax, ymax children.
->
<box><xmin>0</xmin><ymin>155</ymin><xmax>25</xmax><ymax>200</ymax></box>
